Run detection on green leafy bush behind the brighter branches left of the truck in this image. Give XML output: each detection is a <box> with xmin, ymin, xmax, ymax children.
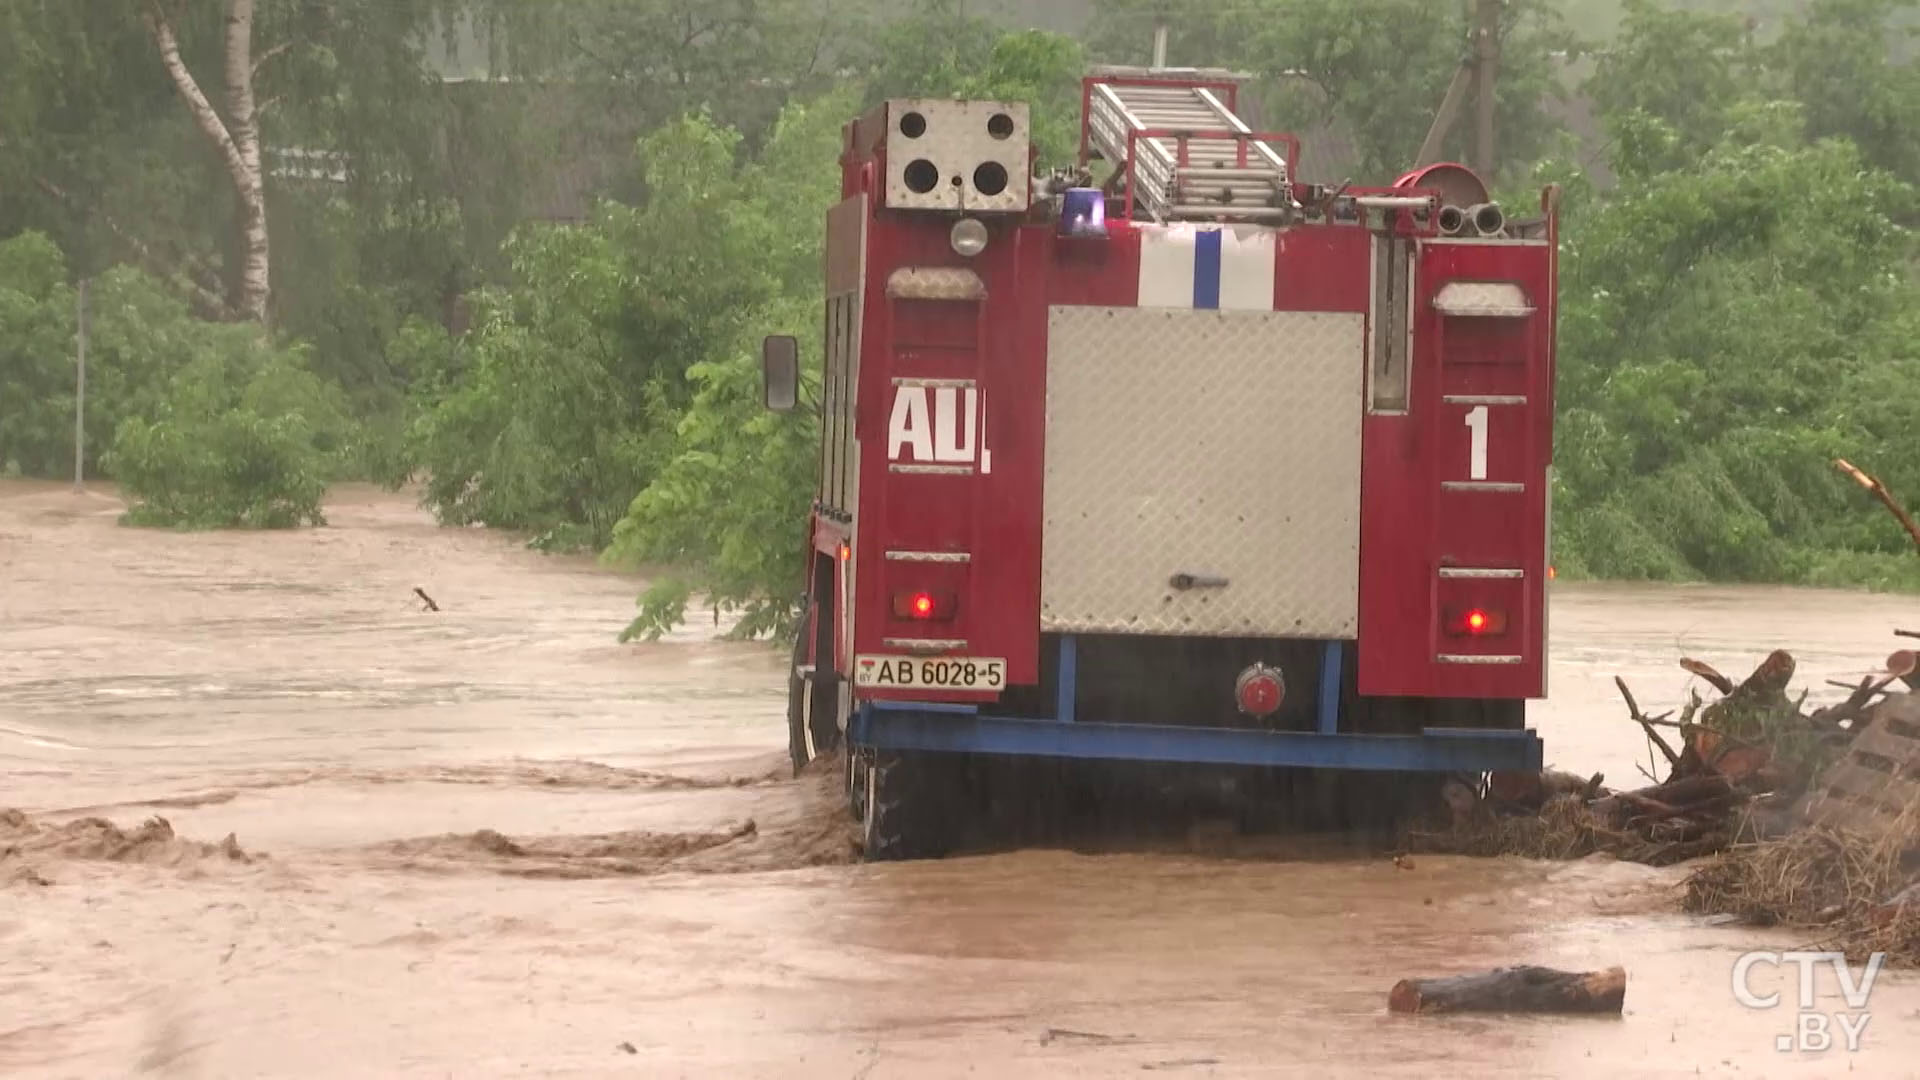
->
<box><xmin>417</xmin><ymin>117</ymin><xmax>774</xmax><ymax>548</ymax></box>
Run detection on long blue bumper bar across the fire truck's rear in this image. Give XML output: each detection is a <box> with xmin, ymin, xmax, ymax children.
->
<box><xmin>849</xmin><ymin>701</ymin><xmax>1542</xmax><ymax>773</ymax></box>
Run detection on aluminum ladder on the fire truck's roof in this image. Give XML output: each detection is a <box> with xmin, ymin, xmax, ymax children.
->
<box><xmin>1087</xmin><ymin>67</ymin><xmax>1292</xmax><ymax>221</ymax></box>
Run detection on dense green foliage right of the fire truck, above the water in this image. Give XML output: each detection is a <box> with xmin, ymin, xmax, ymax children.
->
<box><xmin>1555</xmin><ymin>33</ymin><xmax>1920</xmax><ymax>588</ymax></box>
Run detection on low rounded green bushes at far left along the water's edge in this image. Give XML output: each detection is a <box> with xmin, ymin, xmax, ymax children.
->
<box><xmin>0</xmin><ymin>233</ymin><xmax>359</xmax><ymax>528</ymax></box>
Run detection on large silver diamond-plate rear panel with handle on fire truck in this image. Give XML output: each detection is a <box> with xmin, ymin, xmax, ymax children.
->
<box><xmin>1041</xmin><ymin>307</ymin><xmax>1365</xmax><ymax>638</ymax></box>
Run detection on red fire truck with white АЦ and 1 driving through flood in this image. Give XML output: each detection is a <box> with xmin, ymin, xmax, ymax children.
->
<box><xmin>762</xmin><ymin>67</ymin><xmax>1557</xmax><ymax>857</ymax></box>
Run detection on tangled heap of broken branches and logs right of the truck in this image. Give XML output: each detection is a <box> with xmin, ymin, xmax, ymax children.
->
<box><xmin>1409</xmin><ymin>632</ymin><xmax>1920</xmax><ymax>865</ymax></box>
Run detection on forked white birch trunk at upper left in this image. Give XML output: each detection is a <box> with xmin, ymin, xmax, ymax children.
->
<box><xmin>146</xmin><ymin>0</ymin><xmax>271</xmax><ymax>325</ymax></box>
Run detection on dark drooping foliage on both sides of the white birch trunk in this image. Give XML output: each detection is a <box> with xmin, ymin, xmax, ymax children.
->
<box><xmin>0</xmin><ymin>0</ymin><xmax>556</xmax><ymax>419</ymax></box>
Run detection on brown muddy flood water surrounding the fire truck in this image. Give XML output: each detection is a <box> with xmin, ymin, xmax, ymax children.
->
<box><xmin>0</xmin><ymin>482</ymin><xmax>1920</xmax><ymax>1078</ymax></box>
